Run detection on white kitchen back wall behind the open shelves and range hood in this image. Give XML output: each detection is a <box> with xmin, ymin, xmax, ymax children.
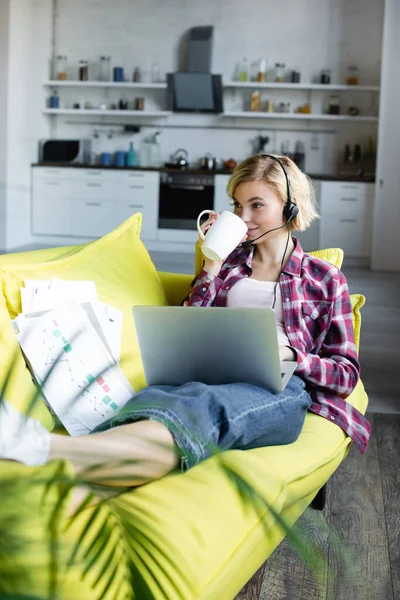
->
<box><xmin>50</xmin><ymin>0</ymin><xmax>383</xmax><ymax>173</ymax></box>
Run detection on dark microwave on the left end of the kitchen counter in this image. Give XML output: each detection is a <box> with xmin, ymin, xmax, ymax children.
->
<box><xmin>39</xmin><ymin>139</ymin><xmax>92</xmax><ymax>164</ymax></box>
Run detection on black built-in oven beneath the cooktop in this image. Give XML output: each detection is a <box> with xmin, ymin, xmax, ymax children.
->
<box><xmin>158</xmin><ymin>172</ymin><xmax>214</xmax><ymax>233</ymax></box>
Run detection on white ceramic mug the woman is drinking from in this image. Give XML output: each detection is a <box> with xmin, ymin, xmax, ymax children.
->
<box><xmin>197</xmin><ymin>210</ymin><xmax>247</xmax><ymax>262</ymax></box>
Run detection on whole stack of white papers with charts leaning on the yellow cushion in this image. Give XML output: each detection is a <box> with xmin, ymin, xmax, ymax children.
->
<box><xmin>13</xmin><ymin>278</ymin><xmax>135</xmax><ymax>435</ymax></box>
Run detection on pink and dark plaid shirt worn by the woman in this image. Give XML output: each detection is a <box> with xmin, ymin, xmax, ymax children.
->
<box><xmin>183</xmin><ymin>237</ymin><xmax>371</xmax><ymax>453</ymax></box>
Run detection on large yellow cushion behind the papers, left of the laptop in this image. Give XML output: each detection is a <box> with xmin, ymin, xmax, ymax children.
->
<box><xmin>0</xmin><ymin>213</ymin><xmax>168</xmax><ymax>426</ymax></box>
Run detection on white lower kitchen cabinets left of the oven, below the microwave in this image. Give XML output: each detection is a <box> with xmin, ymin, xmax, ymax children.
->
<box><xmin>32</xmin><ymin>167</ymin><xmax>159</xmax><ymax>240</ymax></box>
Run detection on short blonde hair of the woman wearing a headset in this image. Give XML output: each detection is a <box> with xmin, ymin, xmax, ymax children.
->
<box><xmin>226</xmin><ymin>154</ymin><xmax>319</xmax><ymax>231</ymax></box>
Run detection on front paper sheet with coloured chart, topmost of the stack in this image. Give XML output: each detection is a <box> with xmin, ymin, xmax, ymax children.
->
<box><xmin>17</xmin><ymin>304</ymin><xmax>134</xmax><ymax>435</ymax></box>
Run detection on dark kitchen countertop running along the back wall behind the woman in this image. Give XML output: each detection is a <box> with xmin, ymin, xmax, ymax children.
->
<box><xmin>31</xmin><ymin>162</ymin><xmax>375</xmax><ymax>183</ymax></box>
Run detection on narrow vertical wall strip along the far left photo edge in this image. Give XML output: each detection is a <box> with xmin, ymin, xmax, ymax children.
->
<box><xmin>0</xmin><ymin>0</ymin><xmax>9</xmax><ymax>251</ymax></box>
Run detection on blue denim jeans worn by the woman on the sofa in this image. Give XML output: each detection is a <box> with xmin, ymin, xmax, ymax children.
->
<box><xmin>95</xmin><ymin>375</ymin><xmax>311</xmax><ymax>470</ymax></box>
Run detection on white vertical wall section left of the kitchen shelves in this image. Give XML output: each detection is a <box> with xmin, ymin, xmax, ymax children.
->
<box><xmin>6</xmin><ymin>0</ymin><xmax>51</xmax><ymax>249</ymax></box>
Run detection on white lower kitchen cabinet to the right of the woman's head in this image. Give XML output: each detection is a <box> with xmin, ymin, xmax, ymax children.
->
<box><xmin>319</xmin><ymin>181</ymin><xmax>375</xmax><ymax>261</ymax></box>
